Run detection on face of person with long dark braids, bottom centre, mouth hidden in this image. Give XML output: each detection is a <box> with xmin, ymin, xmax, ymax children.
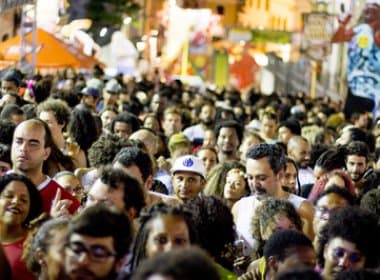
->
<box><xmin>145</xmin><ymin>214</ymin><xmax>190</xmax><ymax>258</ymax></box>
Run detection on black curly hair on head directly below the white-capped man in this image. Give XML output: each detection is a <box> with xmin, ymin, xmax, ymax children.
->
<box><xmin>185</xmin><ymin>196</ymin><xmax>236</xmax><ymax>269</ymax></box>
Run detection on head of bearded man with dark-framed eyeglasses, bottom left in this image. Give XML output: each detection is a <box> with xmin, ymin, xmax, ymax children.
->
<box><xmin>64</xmin><ymin>204</ymin><xmax>132</xmax><ymax>280</ymax></box>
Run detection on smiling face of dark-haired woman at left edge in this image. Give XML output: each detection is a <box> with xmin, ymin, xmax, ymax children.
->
<box><xmin>0</xmin><ymin>181</ymin><xmax>30</xmax><ymax>225</ymax></box>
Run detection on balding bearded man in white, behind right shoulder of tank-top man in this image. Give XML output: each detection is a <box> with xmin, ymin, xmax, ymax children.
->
<box><xmin>287</xmin><ymin>135</ymin><xmax>315</xmax><ymax>190</ymax></box>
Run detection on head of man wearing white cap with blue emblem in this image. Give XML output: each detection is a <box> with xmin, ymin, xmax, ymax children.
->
<box><xmin>171</xmin><ymin>155</ymin><xmax>206</xmax><ymax>201</ymax></box>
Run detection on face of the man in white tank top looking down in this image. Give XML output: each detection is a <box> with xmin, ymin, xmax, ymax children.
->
<box><xmin>247</xmin><ymin>157</ymin><xmax>283</xmax><ymax>200</ymax></box>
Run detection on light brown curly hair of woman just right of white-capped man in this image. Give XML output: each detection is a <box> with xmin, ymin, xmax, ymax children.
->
<box><xmin>203</xmin><ymin>160</ymin><xmax>248</xmax><ymax>197</ymax></box>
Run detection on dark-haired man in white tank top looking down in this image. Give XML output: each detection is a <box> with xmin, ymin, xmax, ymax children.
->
<box><xmin>232</xmin><ymin>143</ymin><xmax>314</xmax><ymax>254</ymax></box>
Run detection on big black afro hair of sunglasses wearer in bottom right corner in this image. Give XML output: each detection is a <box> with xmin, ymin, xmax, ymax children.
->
<box><xmin>317</xmin><ymin>206</ymin><xmax>380</xmax><ymax>268</ymax></box>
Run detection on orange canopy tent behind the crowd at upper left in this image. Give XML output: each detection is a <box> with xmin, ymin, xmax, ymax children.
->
<box><xmin>0</xmin><ymin>29</ymin><xmax>101</xmax><ymax>69</ymax></box>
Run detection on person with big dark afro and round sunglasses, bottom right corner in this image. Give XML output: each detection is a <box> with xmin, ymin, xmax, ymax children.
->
<box><xmin>318</xmin><ymin>206</ymin><xmax>380</xmax><ymax>280</ymax></box>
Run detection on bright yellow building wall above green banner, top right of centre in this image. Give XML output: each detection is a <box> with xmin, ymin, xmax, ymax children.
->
<box><xmin>238</xmin><ymin>0</ymin><xmax>311</xmax><ymax>32</ymax></box>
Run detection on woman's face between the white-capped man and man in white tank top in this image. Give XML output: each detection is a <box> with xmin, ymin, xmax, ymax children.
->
<box><xmin>224</xmin><ymin>169</ymin><xmax>247</xmax><ymax>200</ymax></box>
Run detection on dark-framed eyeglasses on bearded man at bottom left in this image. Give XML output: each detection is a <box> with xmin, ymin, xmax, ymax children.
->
<box><xmin>66</xmin><ymin>241</ymin><xmax>116</xmax><ymax>262</ymax></box>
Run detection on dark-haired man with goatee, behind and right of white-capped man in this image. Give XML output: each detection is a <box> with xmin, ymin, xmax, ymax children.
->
<box><xmin>215</xmin><ymin>120</ymin><xmax>243</xmax><ymax>163</ymax></box>
